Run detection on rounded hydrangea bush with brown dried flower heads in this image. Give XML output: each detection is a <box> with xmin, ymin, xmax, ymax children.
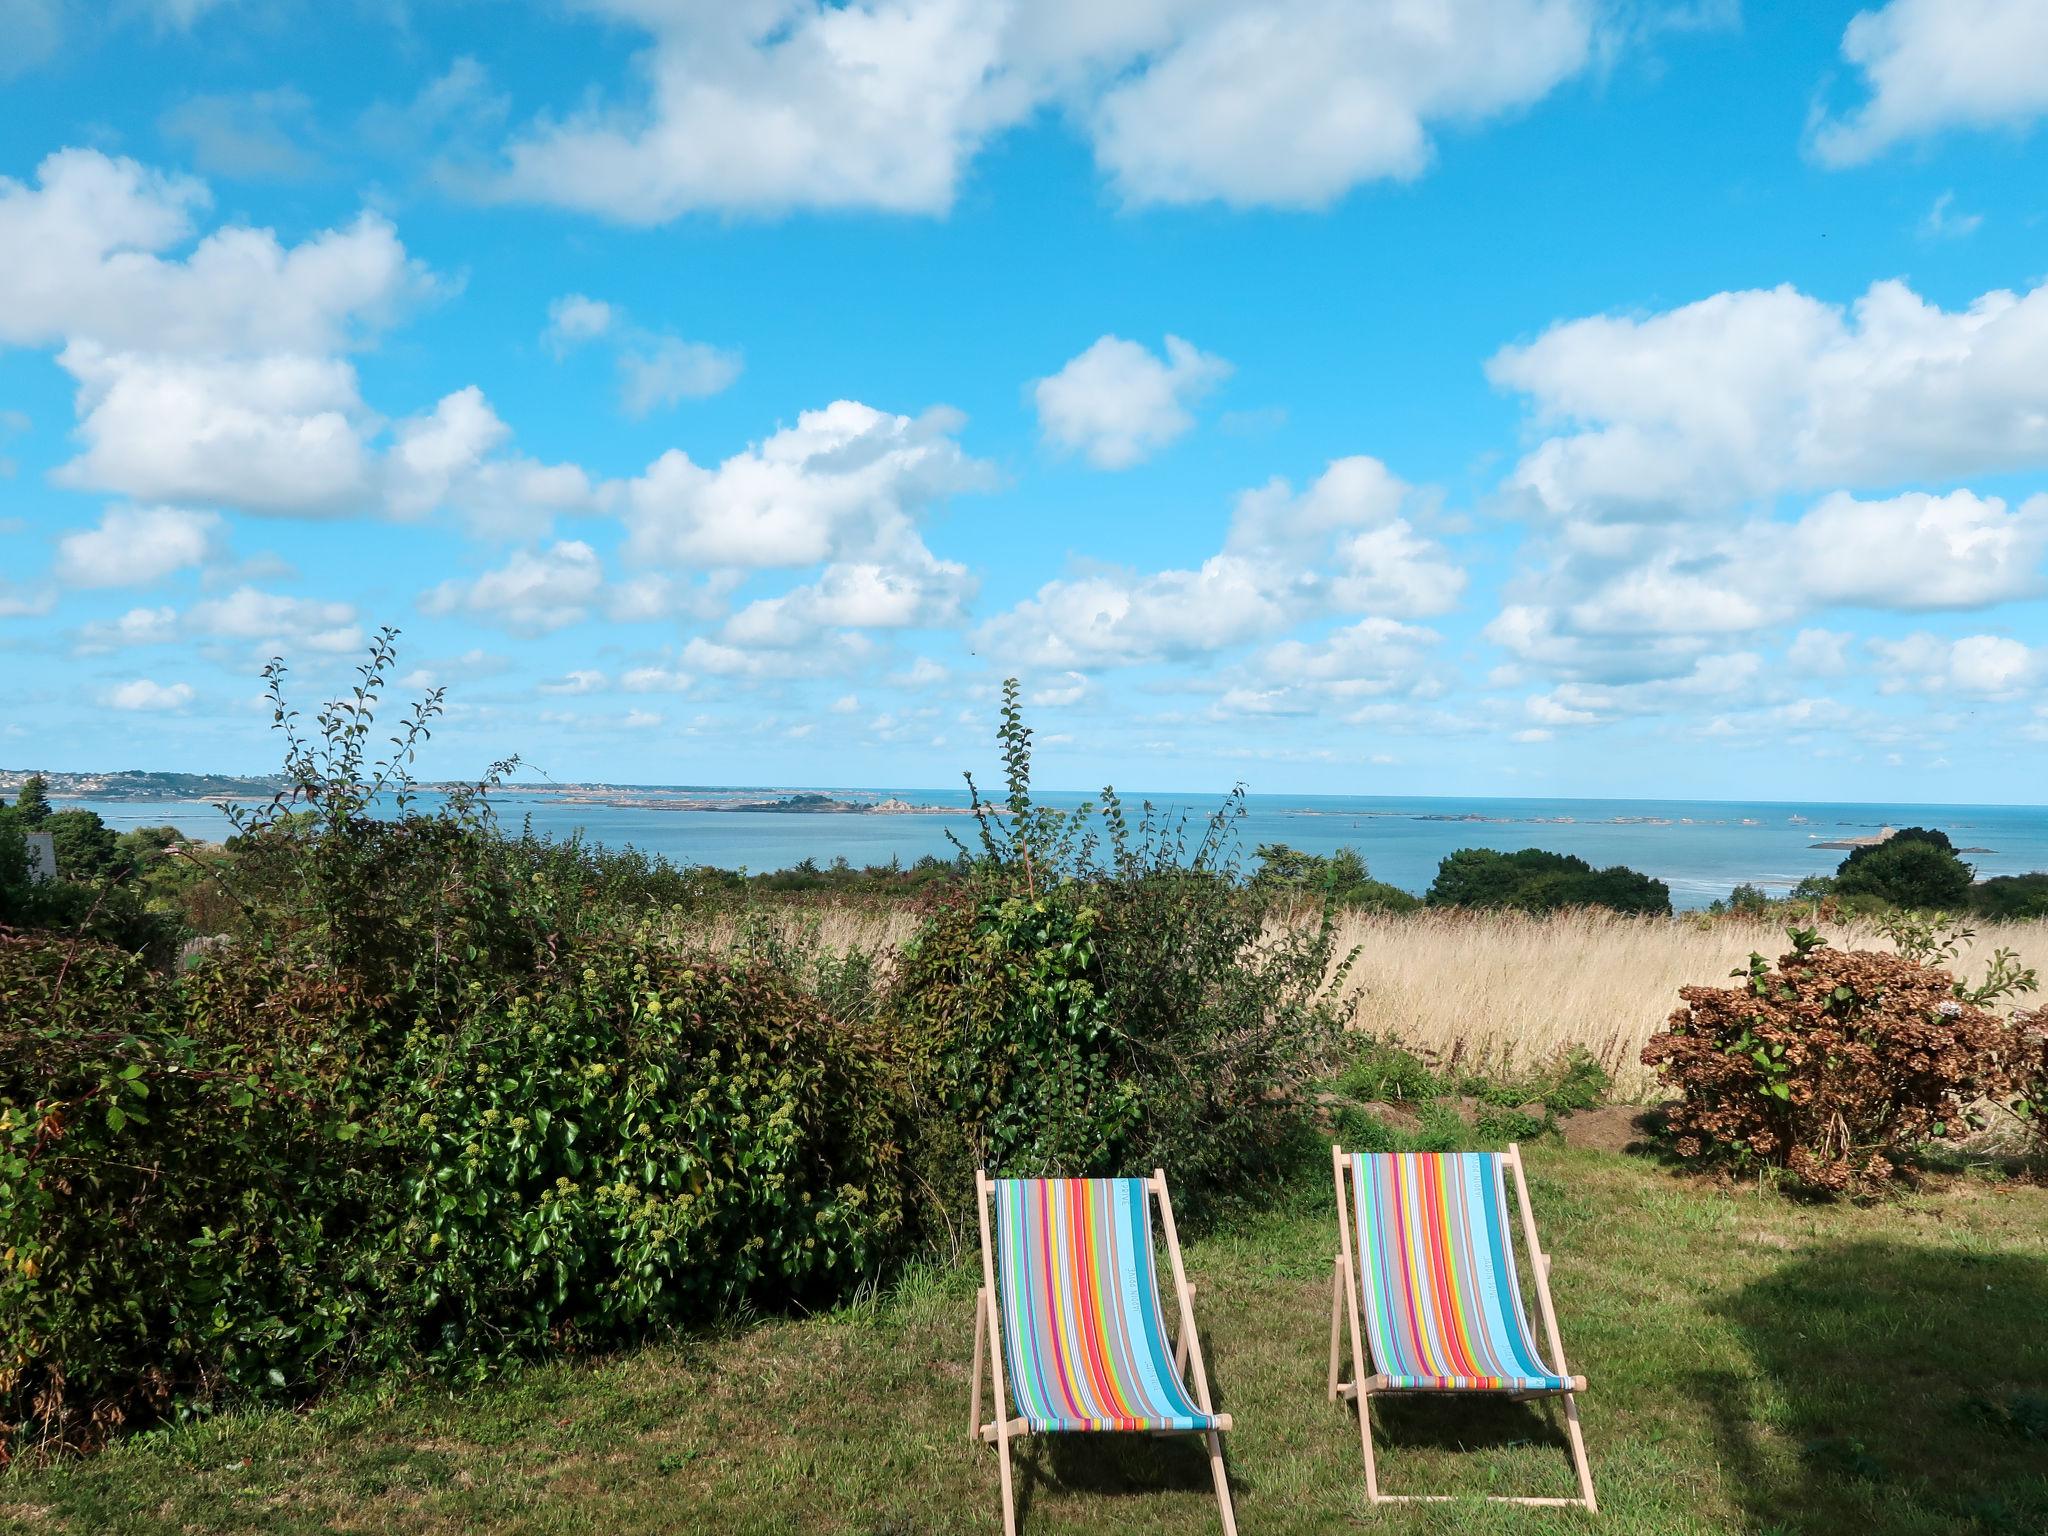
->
<box><xmin>1642</xmin><ymin>930</ymin><xmax>2038</xmax><ymax>1194</ymax></box>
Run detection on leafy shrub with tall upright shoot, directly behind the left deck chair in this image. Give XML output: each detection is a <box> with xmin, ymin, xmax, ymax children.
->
<box><xmin>891</xmin><ymin>682</ymin><xmax>1343</xmax><ymax>1210</ymax></box>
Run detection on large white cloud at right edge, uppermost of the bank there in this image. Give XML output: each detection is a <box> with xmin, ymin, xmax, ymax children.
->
<box><xmin>1487</xmin><ymin>281</ymin><xmax>2048</xmax><ymax>518</ymax></box>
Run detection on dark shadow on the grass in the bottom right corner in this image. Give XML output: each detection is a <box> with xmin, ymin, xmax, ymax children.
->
<box><xmin>1700</xmin><ymin>1241</ymin><xmax>2048</xmax><ymax>1536</ymax></box>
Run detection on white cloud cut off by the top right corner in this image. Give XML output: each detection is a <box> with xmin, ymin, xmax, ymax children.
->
<box><xmin>1812</xmin><ymin>0</ymin><xmax>2048</xmax><ymax>166</ymax></box>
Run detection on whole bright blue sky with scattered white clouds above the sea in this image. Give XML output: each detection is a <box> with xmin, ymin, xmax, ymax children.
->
<box><xmin>0</xmin><ymin>0</ymin><xmax>2048</xmax><ymax>801</ymax></box>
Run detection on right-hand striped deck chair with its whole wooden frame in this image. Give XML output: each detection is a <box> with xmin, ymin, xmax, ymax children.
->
<box><xmin>1329</xmin><ymin>1145</ymin><xmax>1599</xmax><ymax>1511</ymax></box>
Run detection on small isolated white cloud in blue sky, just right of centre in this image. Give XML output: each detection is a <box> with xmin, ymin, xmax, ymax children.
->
<box><xmin>1032</xmin><ymin>336</ymin><xmax>1231</xmax><ymax>469</ymax></box>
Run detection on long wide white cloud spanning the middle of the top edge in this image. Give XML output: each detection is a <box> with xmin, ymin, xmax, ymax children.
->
<box><xmin>496</xmin><ymin>0</ymin><xmax>1595</xmax><ymax>223</ymax></box>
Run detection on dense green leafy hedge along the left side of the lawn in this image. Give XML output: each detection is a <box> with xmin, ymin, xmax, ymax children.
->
<box><xmin>0</xmin><ymin>934</ymin><xmax>905</xmax><ymax>1444</ymax></box>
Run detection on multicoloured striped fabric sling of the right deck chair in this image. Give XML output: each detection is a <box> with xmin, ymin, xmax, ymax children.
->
<box><xmin>1352</xmin><ymin>1153</ymin><xmax>1571</xmax><ymax>1393</ymax></box>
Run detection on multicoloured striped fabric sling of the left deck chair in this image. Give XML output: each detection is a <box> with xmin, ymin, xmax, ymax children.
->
<box><xmin>993</xmin><ymin>1180</ymin><xmax>1214</xmax><ymax>1432</ymax></box>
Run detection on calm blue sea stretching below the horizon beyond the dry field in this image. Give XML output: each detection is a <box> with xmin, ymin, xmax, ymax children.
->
<box><xmin>70</xmin><ymin>788</ymin><xmax>2048</xmax><ymax>907</ymax></box>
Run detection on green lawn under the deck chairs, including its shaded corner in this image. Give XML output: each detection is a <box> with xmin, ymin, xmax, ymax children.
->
<box><xmin>0</xmin><ymin>1145</ymin><xmax>2048</xmax><ymax>1536</ymax></box>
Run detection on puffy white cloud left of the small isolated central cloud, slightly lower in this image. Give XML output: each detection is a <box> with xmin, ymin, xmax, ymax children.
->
<box><xmin>623</xmin><ymin>399</ymin><xmax>991</xmax><ymax>567</ymax></box>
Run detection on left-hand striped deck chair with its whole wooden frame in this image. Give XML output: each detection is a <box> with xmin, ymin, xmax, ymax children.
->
<box><xmin>967</xmin><ymin>1169</ymin><xmax>1237</xmax><ymax>1536</ymax></box>
